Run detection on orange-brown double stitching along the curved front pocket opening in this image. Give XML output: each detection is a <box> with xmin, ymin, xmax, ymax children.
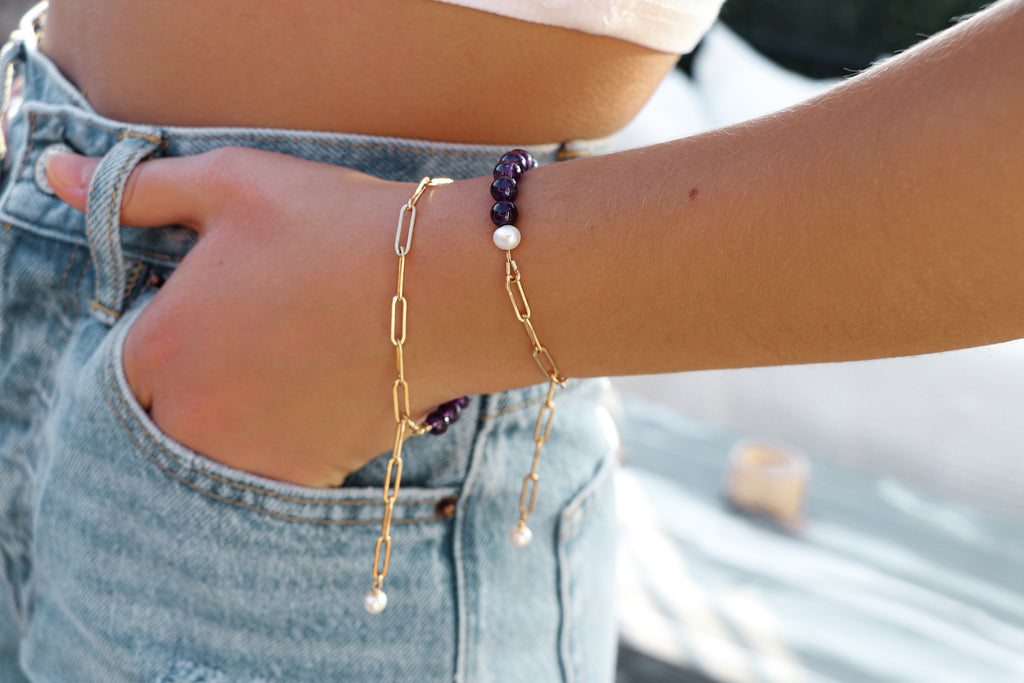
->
<box><xmin>98</xmin><ymin>352</ymin><xmax>439</xmax><ymax>525</ymax></box>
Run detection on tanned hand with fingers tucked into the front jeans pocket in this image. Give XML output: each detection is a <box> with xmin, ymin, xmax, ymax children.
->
<box><xmin>47</xmin><ymin>148</ymin><xmax>452</xmax><ymax>486</ymax></box>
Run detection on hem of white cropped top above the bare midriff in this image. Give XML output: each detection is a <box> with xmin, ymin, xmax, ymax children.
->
<box><xmin>432</xmin><ymin>0</ymin><xmax>724</xmax><ymax>54</ymax></box>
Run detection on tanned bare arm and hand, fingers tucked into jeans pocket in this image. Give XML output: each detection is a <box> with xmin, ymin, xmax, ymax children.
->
<box><xmin>39</xmin><ymin>0</ymin><xmax>1024</xmax><ymax>485</ymax></box>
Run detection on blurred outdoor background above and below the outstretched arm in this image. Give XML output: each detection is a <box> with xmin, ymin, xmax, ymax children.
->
<box><xmin>6</xmin><ymin>0</ymin><xmax>1024</xmax><ymax>683</ymax></box>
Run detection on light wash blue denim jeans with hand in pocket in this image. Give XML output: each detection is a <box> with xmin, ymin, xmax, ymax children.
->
<box><xmin>0</xmin><ymin>3</ymin><xmax>615</xmax><ymax>683</ymax></box>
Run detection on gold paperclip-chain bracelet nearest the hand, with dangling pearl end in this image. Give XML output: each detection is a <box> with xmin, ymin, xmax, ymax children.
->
<box><xmin>362</xmin><ymin>177</ymin><xmax>458</xmax><ymax>614</ymax></box>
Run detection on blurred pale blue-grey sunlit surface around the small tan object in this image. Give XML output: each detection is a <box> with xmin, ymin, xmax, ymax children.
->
<box><xmin>616</xmin><ymin>398</ymin><xmax>1024</xmax><ymax>683</ymax></box>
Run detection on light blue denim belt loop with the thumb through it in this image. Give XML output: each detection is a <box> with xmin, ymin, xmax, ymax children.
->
<box><xmin>85</xmin><ymin>131</ymin><xmax>161</xmax><ymax>325</ymax></box>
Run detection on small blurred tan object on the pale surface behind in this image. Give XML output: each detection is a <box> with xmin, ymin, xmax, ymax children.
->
<box><xmin>725</xmin><ymin>440</ymin><xmax>810</xmax><ymax>530</ymax></box>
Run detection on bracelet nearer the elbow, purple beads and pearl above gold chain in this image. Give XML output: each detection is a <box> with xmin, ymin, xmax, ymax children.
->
<box><xmin>490</xmin><ymin>150</ymin><xmax>566</xmax><ymax>547</ymax></box>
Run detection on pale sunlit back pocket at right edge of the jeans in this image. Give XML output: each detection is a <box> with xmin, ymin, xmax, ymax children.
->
<box><xmin>558</xmin><ymin>448</ymin><xmax>616</xmax><ymax>683</ymax></box>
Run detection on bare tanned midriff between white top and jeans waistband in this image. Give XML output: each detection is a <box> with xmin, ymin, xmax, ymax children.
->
<box><xmin>43</xmin><ymin>0</ymin><xmax>677</xmax><ymax>144</ymax></box>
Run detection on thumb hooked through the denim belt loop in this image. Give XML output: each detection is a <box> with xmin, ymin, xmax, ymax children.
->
<box><xmin>46</xmin><ymin>152</ymin><xmax>206</xmax><ymax>229</ymax></box>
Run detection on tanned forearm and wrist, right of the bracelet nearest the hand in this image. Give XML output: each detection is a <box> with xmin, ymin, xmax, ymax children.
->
<box><xmin>409</xmin><ymin>2</ymin><xmax>1024</xmax><ymax>401</ymax></box>
